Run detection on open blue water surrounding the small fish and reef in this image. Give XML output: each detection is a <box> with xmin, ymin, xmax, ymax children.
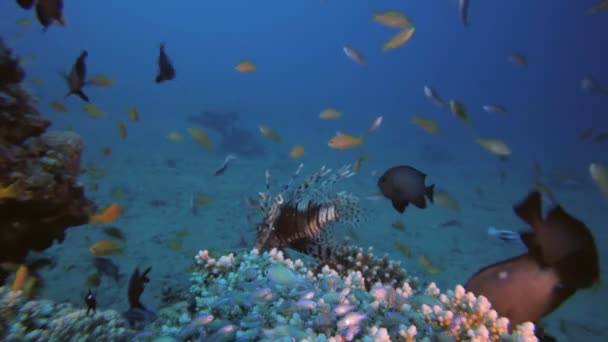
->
<box><xmin>0</xmin><ymin>0</ymin><xmax>608</xmax><ymax>340</ymax></box>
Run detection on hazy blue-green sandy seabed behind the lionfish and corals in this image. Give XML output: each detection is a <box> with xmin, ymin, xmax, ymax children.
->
<box><xmin>29</xmin><ymin>150</ymin><xmax>608</xmax><ymax>341</ymax></box>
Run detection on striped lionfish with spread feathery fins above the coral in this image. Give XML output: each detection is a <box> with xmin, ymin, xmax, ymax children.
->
<box><xmin>255</xmin><ymin>164</ymin><xmax>363</xmax><ymax>261</ymax></box>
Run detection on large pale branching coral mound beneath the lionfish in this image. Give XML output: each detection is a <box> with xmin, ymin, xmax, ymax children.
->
<box><xmin>155</xmin><ymin>249</ymin><xmax>536</xmax><ymax>341</ymax></box>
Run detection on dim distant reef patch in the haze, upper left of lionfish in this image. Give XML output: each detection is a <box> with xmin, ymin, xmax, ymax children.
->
<box><xmin>186</xmin><ymin>111</ymin><xmax>266</xmax><ymax>156</ymax></box>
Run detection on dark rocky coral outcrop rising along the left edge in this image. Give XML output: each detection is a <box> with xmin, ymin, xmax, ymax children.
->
<box><xmin>0</xmin><ymin>40</ymin><xmax>95</xmax><ymax>262</ymax></box>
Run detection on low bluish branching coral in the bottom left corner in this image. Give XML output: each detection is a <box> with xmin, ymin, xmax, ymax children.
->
<box><xmin>0</xmin><ymin>287</ymin><xmax>136</xmax><ymax>342</ymax></box>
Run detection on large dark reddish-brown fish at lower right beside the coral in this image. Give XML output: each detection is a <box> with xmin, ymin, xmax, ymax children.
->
<box><xmin>465</xmin><ymin>191</ymin><xmax>599</xmax><ymax>328</ymax></box>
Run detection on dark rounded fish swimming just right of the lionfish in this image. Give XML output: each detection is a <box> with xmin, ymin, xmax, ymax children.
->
<box><xmin>378</xmin><ymin>165</ymin><xmax>435</xmax><ymax>213</ymax></box>
